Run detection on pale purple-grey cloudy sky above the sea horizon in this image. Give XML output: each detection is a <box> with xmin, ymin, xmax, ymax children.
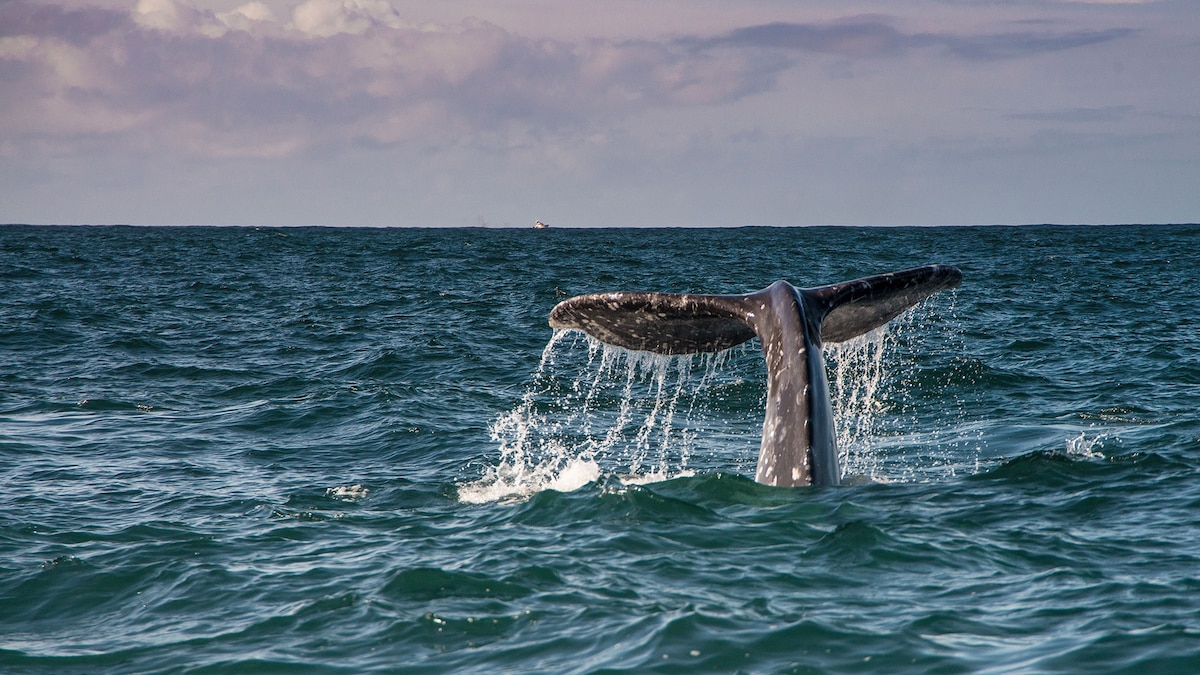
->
<box><xmin>0</xmin><ymin>0</ymin><xmax>1200</xmax><ymax>227</ymax></box>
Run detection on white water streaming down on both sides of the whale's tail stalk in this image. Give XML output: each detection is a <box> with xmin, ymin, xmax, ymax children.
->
<box><xmin>457</xmin><ymin>315</ymin><xmax>945</xmax><ymax>503</ymax></box>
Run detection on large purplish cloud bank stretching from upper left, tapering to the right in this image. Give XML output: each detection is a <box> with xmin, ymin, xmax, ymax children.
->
<box><xmin>0</xmin><ymin>0</ymin><xmax>1130</xmax><ymax>157</ymax></box>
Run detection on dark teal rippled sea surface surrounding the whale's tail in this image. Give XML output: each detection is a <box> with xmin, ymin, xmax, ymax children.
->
<box><xmin>0</xmin><ymin>226</ymin><xmax>1200</xmax><ymax>674</ymax></box>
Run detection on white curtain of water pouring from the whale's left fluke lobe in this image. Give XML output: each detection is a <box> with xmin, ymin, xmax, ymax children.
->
<box><xmin>458</xmin><ymin>331</ymin><xmax>733</xmax><ymax>503</ymax></box>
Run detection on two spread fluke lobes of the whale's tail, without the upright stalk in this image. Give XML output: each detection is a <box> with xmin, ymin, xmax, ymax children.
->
<box><xmin>550</xmin><ymin>265</ymin><xmax>962</xmax><ymax>354</ymax></box>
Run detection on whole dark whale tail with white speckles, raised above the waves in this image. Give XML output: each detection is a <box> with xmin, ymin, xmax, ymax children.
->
<box><xmin>550</xmin><ymin>265</ymin><xmax>962</xmax><ymax>485</ymax></box>
